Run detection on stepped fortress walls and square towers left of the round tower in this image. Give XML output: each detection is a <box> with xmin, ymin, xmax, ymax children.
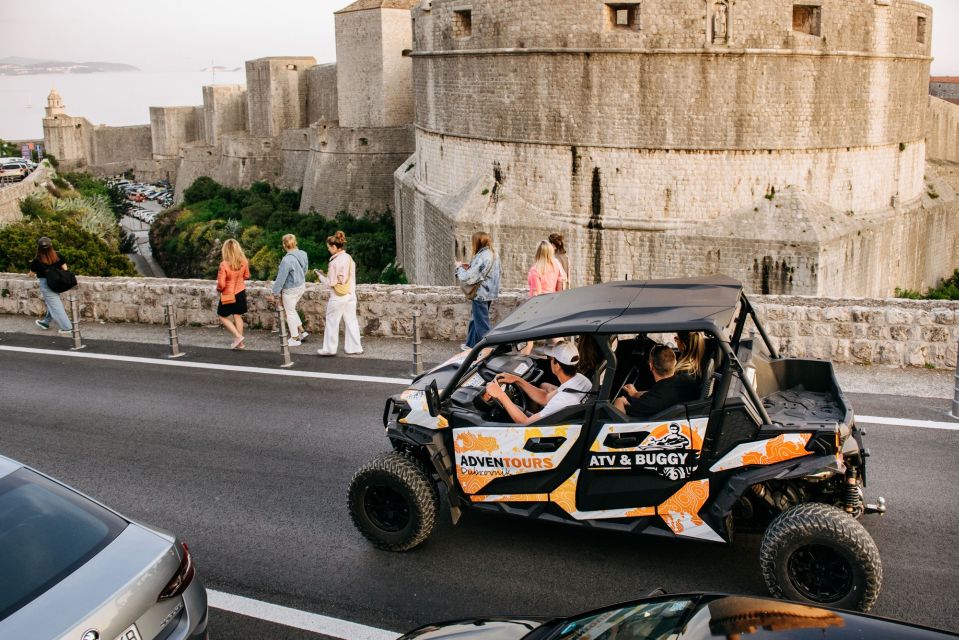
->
<box><xmin>44</xmin><ymin>0</ymin><xmax>415</xmax><ymax>215</ymax></box>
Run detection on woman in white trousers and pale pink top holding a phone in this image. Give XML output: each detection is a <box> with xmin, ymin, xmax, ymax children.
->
<box><xmin>316</xmin><ymin>231</ymin><xmax>363</xmax><ymax>356</ymax></box>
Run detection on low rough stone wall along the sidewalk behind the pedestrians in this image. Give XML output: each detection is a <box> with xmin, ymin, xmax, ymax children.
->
<box><xmin>0</xmin><ymin>273</ymin><xmax>959</xmax><ymax>369</ymax></box>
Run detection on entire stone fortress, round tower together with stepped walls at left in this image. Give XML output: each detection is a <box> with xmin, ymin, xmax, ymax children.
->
<box><xmin>35</xmin><ymin>0</ymin><xmax>959</xmax><ymax>296</ymax></box>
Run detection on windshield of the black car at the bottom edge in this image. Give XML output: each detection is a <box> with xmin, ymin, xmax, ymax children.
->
<box><xmin>550</xmin><ymin>598</ymin><xmax>694</xmax><ymax>640</ymax></box>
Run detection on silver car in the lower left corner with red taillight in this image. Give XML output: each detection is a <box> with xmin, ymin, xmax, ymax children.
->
<box><xmin>0</xmin><ymin>456</ymin><xmax>207</xmax><ymax>640</ymax></box>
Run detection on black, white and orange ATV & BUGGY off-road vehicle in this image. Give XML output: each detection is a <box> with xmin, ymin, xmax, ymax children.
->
<box><xmin>348</xmin><ymin>276</ymin><xmax>885</xmax><ymax>611</ymax></box>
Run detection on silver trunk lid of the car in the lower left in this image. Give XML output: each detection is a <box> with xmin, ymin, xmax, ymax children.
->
<box><xmin>0</xmin><ymin>523</ymin><xmax>180</xmax><ymax>640</ymax></box>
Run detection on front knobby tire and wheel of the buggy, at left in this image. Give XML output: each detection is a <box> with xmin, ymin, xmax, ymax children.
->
<box><xmin>349</xmin><ymin>451</ymin><xmax>439</xmax><ymax>551</ymax></box>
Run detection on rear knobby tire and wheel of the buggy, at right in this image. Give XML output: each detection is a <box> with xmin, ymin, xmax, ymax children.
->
<box><xmin>759</xmin><ymin>502</ymin><xmax>882</xmax><ymax>611</ymax></box>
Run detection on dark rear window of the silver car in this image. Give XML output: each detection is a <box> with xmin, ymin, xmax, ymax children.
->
<box><xmin>0</xmin><ymin>469</ymin><xmax>127</xmax><ymax>620</ymax></box>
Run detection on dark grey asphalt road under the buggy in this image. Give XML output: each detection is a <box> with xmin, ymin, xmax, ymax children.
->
<box><xmin>0</xmin><ymin>335</ymin><xmax>959</xmax><ymax>640</ymax></box>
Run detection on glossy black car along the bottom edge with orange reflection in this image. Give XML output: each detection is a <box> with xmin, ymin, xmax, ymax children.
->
<box><xmin>400</xmin><ymin>593</ymin><xmax>959</xmax><ymax>640</ymax></box>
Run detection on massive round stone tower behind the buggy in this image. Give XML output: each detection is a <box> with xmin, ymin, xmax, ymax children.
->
<box><xmin>396</xmin><ymin>0</ymin><xmax>932</xmax><ymax>294</ymax></box>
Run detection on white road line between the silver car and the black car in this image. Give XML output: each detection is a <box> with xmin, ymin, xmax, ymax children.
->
<box><xmin>206</xmin><ymin>589</ymin><xmax>400</xmax><ymax>640</ymax></box>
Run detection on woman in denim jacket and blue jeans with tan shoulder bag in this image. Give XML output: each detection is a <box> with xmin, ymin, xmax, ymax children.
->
<box><xmin>453</xmin><ymin>231</ymin><xmax>500</xmax><ymax>349</ymax></box>
